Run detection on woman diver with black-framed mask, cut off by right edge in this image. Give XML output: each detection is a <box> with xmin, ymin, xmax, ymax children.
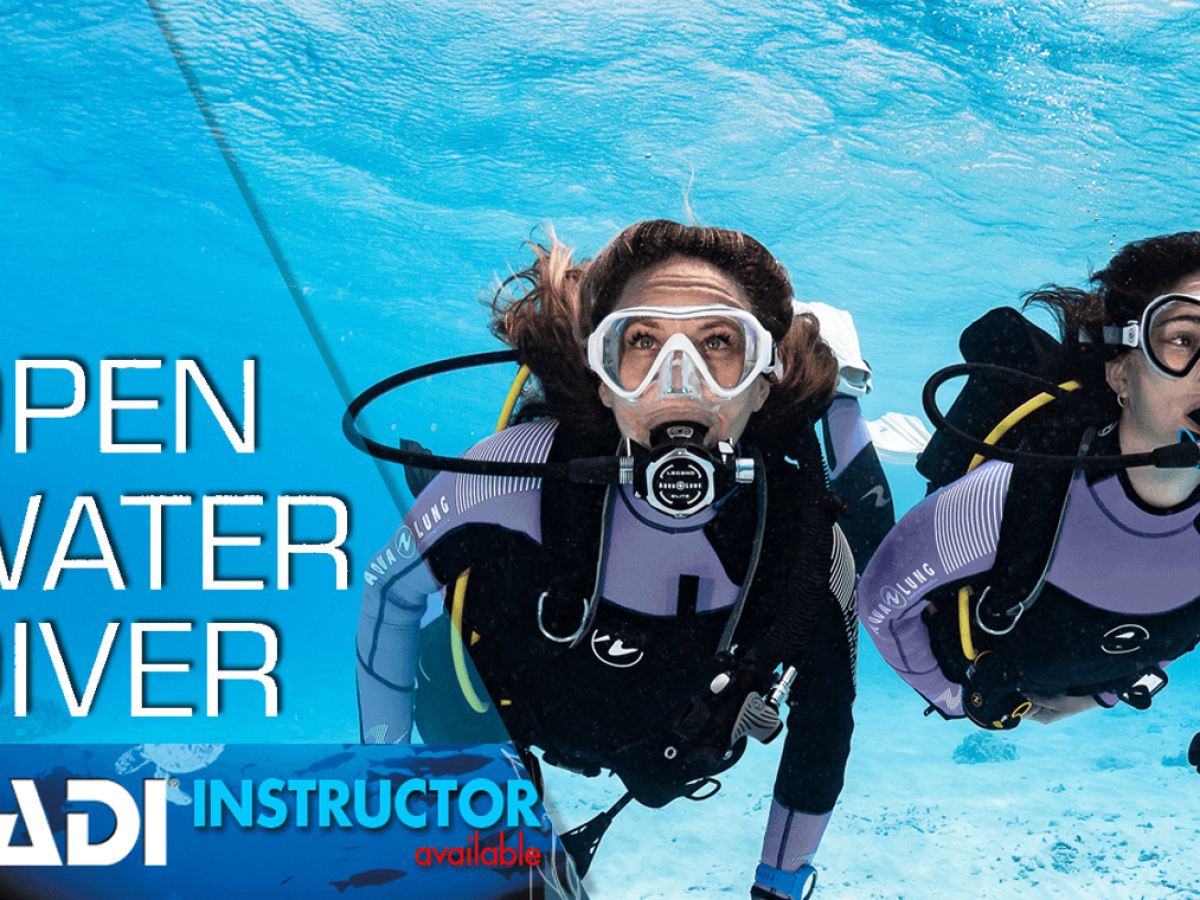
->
<box><xmin>858</xmin><ymin>232</ymin><xmax>1200</xmax><ymax>730</ymax></box>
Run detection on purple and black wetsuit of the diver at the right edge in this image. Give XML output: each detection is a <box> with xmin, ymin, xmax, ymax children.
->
<box><xmin>858</xmin><ymin>461</ymin><xmax>1200</xmax><ymax>716</ymax></box>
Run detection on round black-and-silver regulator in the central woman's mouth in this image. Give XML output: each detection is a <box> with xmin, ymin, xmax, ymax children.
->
<box><xmin>620</xmin><ymin>422</ymin><xmax>754</xmax><ymax>518</ymax></box>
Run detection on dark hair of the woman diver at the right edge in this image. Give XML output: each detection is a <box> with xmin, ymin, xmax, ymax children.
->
<box><xmin>1022</xmin><ymin>232</ymin><xmax>1200</xmax><ymax>418</ymax></box>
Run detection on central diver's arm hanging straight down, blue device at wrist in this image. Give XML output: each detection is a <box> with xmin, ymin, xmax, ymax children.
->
<box><xmin>756</xmin><ymin>532</ymin><xmax>858</xmax><ymax>898</ymax></box>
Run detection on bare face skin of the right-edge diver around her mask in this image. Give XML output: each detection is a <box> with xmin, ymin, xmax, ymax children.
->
<box><xmin>1108</xmin><ymin>272</ymin><xmax>1200</xmax><ymax>451</ymax></box>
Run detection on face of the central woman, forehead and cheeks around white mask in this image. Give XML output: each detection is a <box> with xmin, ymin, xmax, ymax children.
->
<box><xmin>600</xmin><ymin>256</ymin><xmax>770</xmax><ymax>446</ymax></box>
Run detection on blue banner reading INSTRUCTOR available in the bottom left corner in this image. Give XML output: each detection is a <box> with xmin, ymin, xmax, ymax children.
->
<box><xmin>0</xmin><ymin>744</ymin><xmax>578</xmax><ymax>900</ymax></box>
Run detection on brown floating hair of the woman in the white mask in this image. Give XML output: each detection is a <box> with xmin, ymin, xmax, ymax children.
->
<box><xmin>492</xmin><ymin>220</ymin><xmax>838</xmax><ymax>442</ymax></box>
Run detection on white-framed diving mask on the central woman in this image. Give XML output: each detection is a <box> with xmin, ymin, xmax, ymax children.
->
<box><xmin>588</xmin><ymin>304</ymin><xmax>780</xmax><ymax>401</ymax></box>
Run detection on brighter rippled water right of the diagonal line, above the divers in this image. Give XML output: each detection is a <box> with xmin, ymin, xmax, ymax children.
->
<box><xmin>108</xmin><ymin>2</ymin><xmax>1198</xmax><ymax>511</ymax></box>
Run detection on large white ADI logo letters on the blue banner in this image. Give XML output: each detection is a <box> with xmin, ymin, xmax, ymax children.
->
<box><xmin>0</xmin><ymin>778</ymin><xmax>167</xmax><ymax>866</ymax></box>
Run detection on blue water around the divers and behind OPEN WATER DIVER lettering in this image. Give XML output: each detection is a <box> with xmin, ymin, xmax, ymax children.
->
<box><xmin>0</xmin><ymin>0</ymin><xmax>1200</xmax><ymax>896</ymax></box>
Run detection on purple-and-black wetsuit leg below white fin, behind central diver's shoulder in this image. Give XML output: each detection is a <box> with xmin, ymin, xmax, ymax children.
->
<box><xmin>822</xmin><ymin>396</ymin><xmax>895</xmax><ymax>572</ymax></box>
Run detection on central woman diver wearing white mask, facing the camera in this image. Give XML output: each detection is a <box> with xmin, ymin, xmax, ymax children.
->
<box><xmin>348</xmin><ymin>221</ymin><xmax>892</xmax><ymax>900</ymax></box>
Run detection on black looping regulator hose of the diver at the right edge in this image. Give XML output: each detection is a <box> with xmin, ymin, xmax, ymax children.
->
<box><xmin>920</xmin><ymin>362</ymin><xmax>1200</xmax><ymax>470</ymax></box>
